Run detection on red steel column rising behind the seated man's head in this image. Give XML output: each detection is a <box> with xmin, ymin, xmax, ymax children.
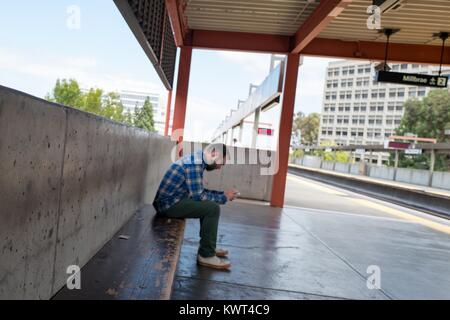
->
<box><xmin>172</xmin><ymin>47</ymin><xmax>192</xmax><ymax>155</ymax></box>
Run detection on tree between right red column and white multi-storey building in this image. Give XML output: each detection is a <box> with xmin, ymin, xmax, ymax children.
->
<box><xmin>292</xmin><ymin>112</ymin><xmax>320</xmax><ymax>145</ymax></box>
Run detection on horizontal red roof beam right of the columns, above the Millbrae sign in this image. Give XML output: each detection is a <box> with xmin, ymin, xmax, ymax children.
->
<box><xmin>302</xmin><ymin>38</ymin><xmax>450</xmax><ymax>65</ymax></box>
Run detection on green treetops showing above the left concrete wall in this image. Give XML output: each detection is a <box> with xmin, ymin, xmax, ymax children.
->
<box><xmin>46</xmin><ymin>79</ymin><xmax>155</xmax><ymax>132</ymax></box>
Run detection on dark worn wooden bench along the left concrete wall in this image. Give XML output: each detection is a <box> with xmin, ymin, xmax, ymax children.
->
<box><xmin>53</xmin><ymin>206</ymin><xmax>185</xmax><ymax>300</ymax></box>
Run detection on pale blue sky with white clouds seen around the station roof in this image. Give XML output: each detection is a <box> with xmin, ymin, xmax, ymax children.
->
<box><xmin>0</xmin><ymin>0</ymin><xmax>338</xmax><ymax>141</ymax></box>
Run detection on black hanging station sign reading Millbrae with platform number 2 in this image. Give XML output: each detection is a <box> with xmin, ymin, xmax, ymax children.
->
<box><xmin>376</xmin><ymin>70</ymin><xmax>448</xmax><ymax>88</ymax></box>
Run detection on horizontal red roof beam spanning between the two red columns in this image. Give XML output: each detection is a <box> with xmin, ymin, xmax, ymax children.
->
<box><xmin>191</xmin><ymin>30</ymin><xmax>290</xmax><ymax>54</ymax></box>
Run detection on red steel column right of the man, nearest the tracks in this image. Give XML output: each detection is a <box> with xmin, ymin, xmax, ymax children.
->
<box><xmin>270</xmin><ymin>54</ymin><xmax>300</xmax><ymax>208</ymax></box>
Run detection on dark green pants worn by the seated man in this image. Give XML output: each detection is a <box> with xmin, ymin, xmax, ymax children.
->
<box><xmin>161</xmin><ymin>199</ymin><xmax>220</xmax><ymax>258</ymax></box>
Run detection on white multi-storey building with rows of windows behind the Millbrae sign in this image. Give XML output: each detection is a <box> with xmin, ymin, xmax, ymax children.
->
<box><xmin>319</xmin><ymin>60</ymin><xmax>450</xmax><ymax>152</ymax></box>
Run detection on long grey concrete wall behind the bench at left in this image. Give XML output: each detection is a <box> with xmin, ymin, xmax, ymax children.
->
<box><xmin>0</xmin><ymin>86</ymin><xmax>174</xmax><ymax>299</ymax></box>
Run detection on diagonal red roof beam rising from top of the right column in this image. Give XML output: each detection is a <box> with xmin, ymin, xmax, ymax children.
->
<box><xmin>292</xmin><ymin>0</ymin><xmax>352</xmax><ymax>53</ymax></box>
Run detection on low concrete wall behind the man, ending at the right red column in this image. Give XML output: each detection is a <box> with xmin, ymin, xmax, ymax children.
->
<box><xmin>183</xmin><ymin>142</ymin><xmax>276</xmax><ymax>201</ymax></box>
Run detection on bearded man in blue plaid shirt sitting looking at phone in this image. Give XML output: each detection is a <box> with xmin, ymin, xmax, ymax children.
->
<box><xmin>153</xmin><ymin>143</ymin><xmax>238</xmax><ymax>269</ymax></box>
